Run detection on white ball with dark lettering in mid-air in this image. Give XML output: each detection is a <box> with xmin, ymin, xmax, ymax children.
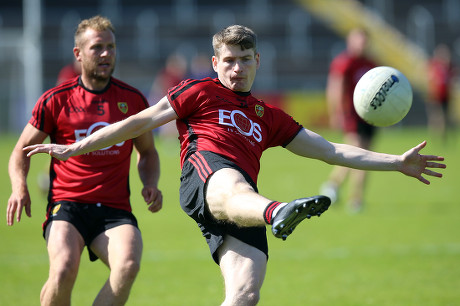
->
<box><xmin>353</xmin><ymin>66</ymin><xmax>412</xmax><ymax>127</ymax></box>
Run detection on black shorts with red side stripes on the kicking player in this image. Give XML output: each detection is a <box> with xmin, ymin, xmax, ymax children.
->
<box><xmin>180</xmin><ymin>151</ymin><xmax>268</xmax><ymax>264</ymax></box>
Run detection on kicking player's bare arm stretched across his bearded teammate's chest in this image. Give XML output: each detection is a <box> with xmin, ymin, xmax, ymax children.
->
<box><xmin>24</xmin><ymin>97</ymin><xmax>178</xmax><ymax>160</ymax></box>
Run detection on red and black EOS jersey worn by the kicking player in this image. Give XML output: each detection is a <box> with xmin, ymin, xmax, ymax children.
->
<box><xmin>167</xmin><ymin>78</ymin><xmax>301</xmax><ymax>182</ymax></box>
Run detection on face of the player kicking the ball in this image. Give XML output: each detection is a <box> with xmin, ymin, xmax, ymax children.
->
<box><xmin>212</xmin><ymin>45</ymin><xmax>260</xmax><ymax>92</ymax></box>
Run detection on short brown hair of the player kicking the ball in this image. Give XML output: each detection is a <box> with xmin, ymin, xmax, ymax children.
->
<box><xmin>212</xmin><ymin>25</ymin><xmax>257</xmax><ymax>56</ymax></box>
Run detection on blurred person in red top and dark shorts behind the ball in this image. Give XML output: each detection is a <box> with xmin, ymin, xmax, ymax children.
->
<box><xmin>321</xmin><ymin>29</ymin><xmax>376</xmax><ymax>212</ymax></box>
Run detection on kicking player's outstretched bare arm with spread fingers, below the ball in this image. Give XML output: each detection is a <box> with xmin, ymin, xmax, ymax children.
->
<box><xmin>286</xmin><ymin>129</ymin><xmax>446</xmax><ymax>184</ymax></box>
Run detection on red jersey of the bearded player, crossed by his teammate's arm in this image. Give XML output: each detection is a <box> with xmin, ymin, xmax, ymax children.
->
<box><xmin>29</xmin><ymin>77</ymin><xmax>148</xmax><ymax>211</ymax></box>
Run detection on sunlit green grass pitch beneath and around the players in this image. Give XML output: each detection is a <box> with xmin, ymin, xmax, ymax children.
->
<box><xmin>0</xmin><ymin>128</ymin><xmax>460</xmax><ymax>306</ymax></box>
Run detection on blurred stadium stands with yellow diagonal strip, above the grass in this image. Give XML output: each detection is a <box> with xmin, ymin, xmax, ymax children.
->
<box><xmin>0</xmin><ymin>0</ymin><xmax>460</xmax><ymax>133</ymax></box>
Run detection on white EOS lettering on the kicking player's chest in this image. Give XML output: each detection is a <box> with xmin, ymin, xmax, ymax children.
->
<box><xmin>219</xmin><ymin>109</ymin><xmax>262</xmax><ymax>142</ymax></box>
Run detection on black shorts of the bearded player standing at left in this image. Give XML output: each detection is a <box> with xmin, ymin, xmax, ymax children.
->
<box><xmin>43</xmin><ymin>201</ymin><xmax>139</xmax><ymax>261</ymax></box>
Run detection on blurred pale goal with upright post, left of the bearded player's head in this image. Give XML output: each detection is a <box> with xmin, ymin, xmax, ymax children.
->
<box><xmin>0</xmin><ymin>0</ymin><xmax>43</xmax><ymax>132</ymax></box>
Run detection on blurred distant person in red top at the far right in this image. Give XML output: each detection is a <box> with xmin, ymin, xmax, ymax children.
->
<box><xmin>427</xmin><ymin>44</ymin><xmax>455</xmax><ymax>141</ymax></box>
